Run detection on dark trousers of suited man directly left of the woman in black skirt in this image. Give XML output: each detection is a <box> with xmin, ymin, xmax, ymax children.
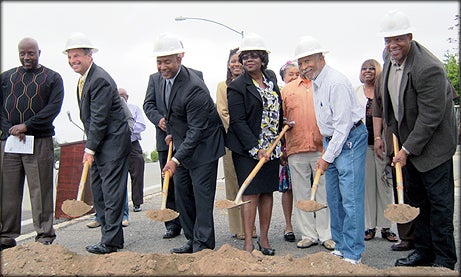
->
<box><xmin>173</xmin><ymin>160</ymin><xmax>218</xmax><ymax>253</ymax></box>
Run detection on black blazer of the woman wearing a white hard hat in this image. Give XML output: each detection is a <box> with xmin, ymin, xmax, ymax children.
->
<box><xmin>226</xmin><ymin>70</ymin><xmax>283</xmax><ymax>156</ymax></box>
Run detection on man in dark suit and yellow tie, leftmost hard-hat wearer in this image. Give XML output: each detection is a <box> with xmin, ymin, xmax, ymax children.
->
<box><xmin>64</xmin><ymin>33</ymin><xmax>131</xmax><ymax>254</ymax></box>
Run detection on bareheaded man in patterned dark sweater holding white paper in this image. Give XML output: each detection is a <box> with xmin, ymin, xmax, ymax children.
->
<box><xmin>0</xmin><ymin>37</ymin><xmax>64</xmax><ymax>248</ymax></box>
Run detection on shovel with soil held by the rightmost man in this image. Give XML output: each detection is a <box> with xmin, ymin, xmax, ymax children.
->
<box><xmin>384</xmin><ymin>134</ymin><xmax>419</xmax><ymax>224</ymax></box>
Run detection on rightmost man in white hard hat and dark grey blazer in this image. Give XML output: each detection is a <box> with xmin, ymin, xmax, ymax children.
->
<box><xmin>378</xmin><ymin>10</ymin><xmax>457</xmax><ymax>269</ymax></box>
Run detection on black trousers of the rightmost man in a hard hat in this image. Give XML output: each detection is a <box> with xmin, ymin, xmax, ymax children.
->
<box><xmin>403</xmin><ymin>158</ymin><xmax>456</xmax><ymax>269</ymax></box>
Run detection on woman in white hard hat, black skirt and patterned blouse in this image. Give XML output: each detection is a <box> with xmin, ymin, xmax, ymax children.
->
<box><xmin>226</xmin><ymin>33</ymin><xmax>283</xmax><ymax>255</ymax></box>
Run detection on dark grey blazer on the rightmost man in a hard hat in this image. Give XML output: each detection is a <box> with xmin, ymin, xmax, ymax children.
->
<box><xmin>383</xmin><ymin>41</ymin><xmax>457</xmax><ymax>172</ymax></box>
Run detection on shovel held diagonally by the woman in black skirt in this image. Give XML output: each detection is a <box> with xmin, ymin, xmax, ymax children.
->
<box><xmin>215</xmin><ymin>125</ymin><xmax>290</xmax><ymax>209</ymax></box>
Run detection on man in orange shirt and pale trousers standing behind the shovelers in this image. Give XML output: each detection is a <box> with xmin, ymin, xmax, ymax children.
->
<box><xmin>281</xmin><ymin>70</ymin><xmax>335</xmax><ymax>250</ymax></box>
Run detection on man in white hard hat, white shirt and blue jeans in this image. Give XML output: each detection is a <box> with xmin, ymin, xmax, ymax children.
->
<box><xmin>294</xmin><ymin>36</ymin><xmax>368</xmax><ymax>264</ymax></box>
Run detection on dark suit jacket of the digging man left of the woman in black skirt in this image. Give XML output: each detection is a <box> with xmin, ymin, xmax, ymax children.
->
<box><xmin>166</xmin><ymin>66</ymin><xmax>225</xmax><ymax>169</ymax></box>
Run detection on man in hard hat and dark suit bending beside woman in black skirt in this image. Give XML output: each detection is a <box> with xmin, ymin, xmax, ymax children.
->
<box><xmin>149</xmin><ymin>33</ymin><xmax>225</xmax><ymax>253</ymax></box>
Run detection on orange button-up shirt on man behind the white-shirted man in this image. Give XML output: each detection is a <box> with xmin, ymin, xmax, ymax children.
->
<box><xmin>281</xmin><ymin>77</ymin><xmax>323</xmax><ymax>156</ymax></box>
